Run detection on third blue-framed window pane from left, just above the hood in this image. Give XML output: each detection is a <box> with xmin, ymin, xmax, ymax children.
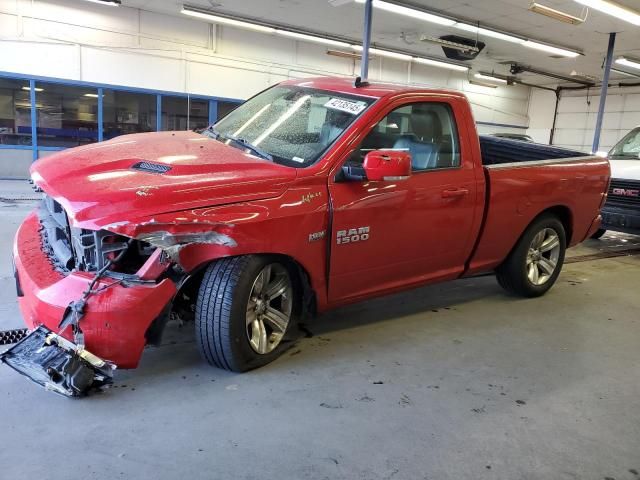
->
<box><xmin>102</xmin><ymin>90</ymin><xmax>157</xmax><ymax>140</ymax></box>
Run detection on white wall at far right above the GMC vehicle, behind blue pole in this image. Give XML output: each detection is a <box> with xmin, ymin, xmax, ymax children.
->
<box><xmin>529</xmin><ymin>87</ymin><xmax>640</xmax><ymax>152</ymax></box>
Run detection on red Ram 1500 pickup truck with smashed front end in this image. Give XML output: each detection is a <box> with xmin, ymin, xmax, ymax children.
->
<box><xmin>3</xmin><ymin>78</ymin><xmax>609</xmax><ymax>393</ymax></box>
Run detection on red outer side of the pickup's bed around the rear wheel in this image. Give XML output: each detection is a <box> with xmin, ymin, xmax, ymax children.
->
<box><xmin>467</xmin><ymin>142</ymin><xmax>609</xmax><ymax>274</ymax></box>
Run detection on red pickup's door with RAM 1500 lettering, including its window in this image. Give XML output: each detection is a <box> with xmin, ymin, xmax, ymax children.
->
<box><xmin>329</xmin><ymin>96</ymin><xmax>482</xmax><ymax>303</ymax></box>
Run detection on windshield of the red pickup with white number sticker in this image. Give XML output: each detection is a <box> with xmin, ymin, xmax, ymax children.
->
<box><xmin>208</xmin><ymin>86</ymin><xmax>373</xmax><ymax>167</ymax></box>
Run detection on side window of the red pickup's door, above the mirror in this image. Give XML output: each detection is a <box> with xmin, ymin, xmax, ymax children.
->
<box><xmin>348</xmin><ymin>103</ymin><xmax>460</xmax><ymax>171</ymax></box>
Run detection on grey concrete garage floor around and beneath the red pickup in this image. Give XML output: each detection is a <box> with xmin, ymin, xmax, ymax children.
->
<box><xmin>0</xmin><ymin>184</ymin><xmax>640</xmax><ymax>480</ymax></box>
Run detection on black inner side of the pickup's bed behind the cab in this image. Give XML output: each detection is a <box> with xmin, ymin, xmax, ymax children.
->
<box><xmin>480</xmin><ymin>135</ymin><xmax>587</xmax><ymax>165</ymax></box>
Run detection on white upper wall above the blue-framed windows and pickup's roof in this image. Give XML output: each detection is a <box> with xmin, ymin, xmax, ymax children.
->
<box><xmin>0</xmin><ymin>0</ymin><xmax>529</xmax><ymax>127</ymax></box>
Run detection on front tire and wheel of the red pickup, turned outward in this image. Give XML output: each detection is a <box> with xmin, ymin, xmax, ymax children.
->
<box><xmin>195</xmin><ymin>255</ymin><xmax>299</xmax><ymax>372</ymax></box>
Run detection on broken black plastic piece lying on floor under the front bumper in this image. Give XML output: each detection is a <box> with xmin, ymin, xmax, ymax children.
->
<box><xmin>0</xmin><ymin>325</ymin><xmax>116</xmax><ymax>397</ymax></box>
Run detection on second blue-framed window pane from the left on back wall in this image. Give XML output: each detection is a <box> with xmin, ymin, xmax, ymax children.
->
<box><xmin>35</xmin><ymin>82</ymin><xmax>98</xmax><ymax>147</ymax></box>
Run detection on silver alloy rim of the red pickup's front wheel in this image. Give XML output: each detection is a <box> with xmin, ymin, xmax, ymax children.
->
<box><xmin>247</xmin><ymin>263</ymin><xmax>293</xmax><ymax>355</ymax></box>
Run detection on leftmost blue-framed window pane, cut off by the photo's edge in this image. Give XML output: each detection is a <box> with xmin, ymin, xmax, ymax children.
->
<box><xmin>0</xmin><ymin>78</ymin><xmax>31</xmax><ymax>145</ymax></box>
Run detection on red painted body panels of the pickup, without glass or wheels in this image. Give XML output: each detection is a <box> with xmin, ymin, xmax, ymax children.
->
<box><xmin>15</xmin><ymin>78</ymin><xmax>609</xmax><ymax>368</ymax></box>
